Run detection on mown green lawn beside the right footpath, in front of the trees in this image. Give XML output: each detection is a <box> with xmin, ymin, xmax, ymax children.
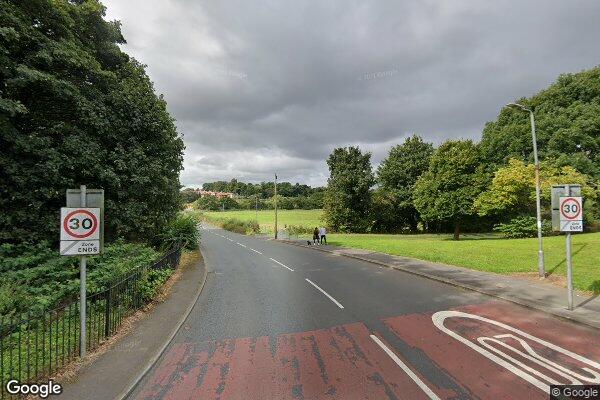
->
<box><xmin>328</xmin><ymin>233</ymin><xmax>600</xmax><ymax>293</ymax></box>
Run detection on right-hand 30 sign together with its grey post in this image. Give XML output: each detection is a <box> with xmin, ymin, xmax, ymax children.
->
<box><xmin>552</xmin><ymin>185</ymin><xmax>583</xmax><ymax>310</ymax></box>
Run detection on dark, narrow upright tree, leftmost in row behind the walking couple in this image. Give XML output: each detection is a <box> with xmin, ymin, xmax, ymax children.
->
<box><xmin>324</xmin><ymin>147</ymin><xmax>375</xmax><ymax>232</ymax></box>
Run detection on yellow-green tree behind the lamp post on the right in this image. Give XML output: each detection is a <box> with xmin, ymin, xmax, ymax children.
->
<box><xmin>474</xmin><ymin>159</ymin><xmax>596</xmax><ymax>220</ymax></box>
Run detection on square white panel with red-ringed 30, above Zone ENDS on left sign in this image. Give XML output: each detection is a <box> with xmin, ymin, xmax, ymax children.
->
<box><xmin>60</xmin><ymin>207</ymin><xmax>100</xmax><ymax>240</ymax></box>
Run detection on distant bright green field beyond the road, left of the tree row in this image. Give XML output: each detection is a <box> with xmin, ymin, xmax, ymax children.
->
<box><xmin>203</xmin><ymin>210</ymin><xmax>323</xmax><ymax>233</ymax></box>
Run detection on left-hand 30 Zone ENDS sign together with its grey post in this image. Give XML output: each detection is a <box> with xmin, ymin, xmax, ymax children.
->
<box><xmin>60</xmin><ymin>185</ymin><xmax>104</xmax><ymax>357</ymax></box>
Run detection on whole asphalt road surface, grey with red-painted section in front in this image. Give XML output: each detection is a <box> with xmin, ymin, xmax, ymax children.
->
<box><xmin>131</xmin><ymin>228</ymin><xmax>600</xmax><ymax>399</ymax></box>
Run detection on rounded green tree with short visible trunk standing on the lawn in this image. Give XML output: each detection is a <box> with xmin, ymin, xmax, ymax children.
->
<box><xmin>413</xmin><ymin>140</ymin><xmax>485</xmax><ymax>240</ymax></box>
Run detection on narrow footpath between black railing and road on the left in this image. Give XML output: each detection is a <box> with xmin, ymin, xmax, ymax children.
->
<box><xmin>60</xmin><ymin>253</ymin><xmax>206</xmax><ymax>400</ymax></box>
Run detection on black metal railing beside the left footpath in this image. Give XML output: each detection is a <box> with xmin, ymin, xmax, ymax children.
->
<box><xmin>0</xmin><ymin>248</ymin><xmax>181</xmax><ymax>399</ymax></box>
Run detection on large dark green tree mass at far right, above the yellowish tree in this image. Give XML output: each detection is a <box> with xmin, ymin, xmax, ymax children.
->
<box><xmin>481</xmin><ymin>67</ymin><xmax>600</xmax><ymax>181</ymax></box>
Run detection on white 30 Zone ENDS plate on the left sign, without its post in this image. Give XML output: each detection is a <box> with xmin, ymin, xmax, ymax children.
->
<box><xmin>60</xmin><ymin>207</ymin><xmax>100</xmax><ymax>256</ymax></box>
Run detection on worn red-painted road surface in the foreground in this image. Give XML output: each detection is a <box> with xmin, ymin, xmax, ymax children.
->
<box><xmin>138</xmin><ymin>302</ymin><xmax>600</xmax><ymax>400</ymax></box>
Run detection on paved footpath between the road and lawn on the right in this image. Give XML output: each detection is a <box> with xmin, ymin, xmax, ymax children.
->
<box><xmin>279</xmin><ymin>239</ymin><xmax>600</xmax><ymax>329</ymax></box>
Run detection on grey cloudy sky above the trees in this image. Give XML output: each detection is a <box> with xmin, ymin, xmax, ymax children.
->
<box><xmin>103</xmin><ymin>0</ymin><xmax>600</xmax><ymax>186</ymax></box>
